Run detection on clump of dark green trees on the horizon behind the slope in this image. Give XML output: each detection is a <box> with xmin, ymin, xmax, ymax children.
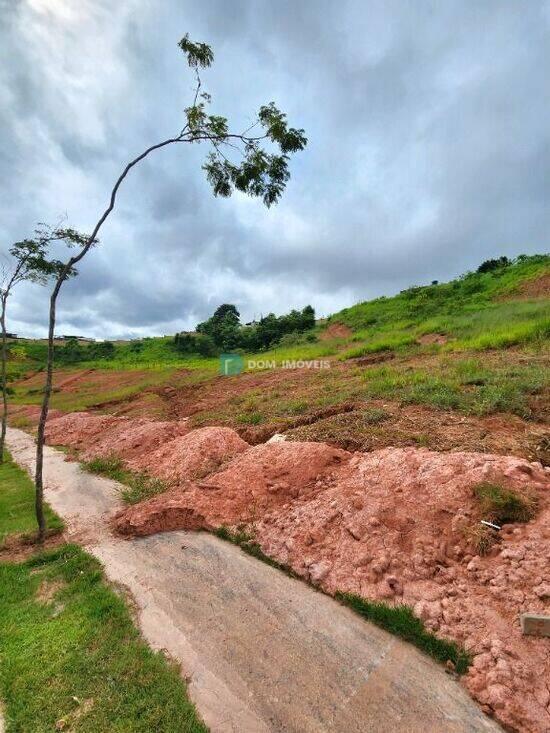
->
<box><xmin>174</xmin><ymin>303</ymin><xmax>315</xmax><ymax>356</ymax></box>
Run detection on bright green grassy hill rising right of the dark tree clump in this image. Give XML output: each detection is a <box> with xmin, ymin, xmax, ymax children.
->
<box><xmin>329</xmin><ymin>255</ymin><xmax>550</xmax><ymax>358</ymax></box>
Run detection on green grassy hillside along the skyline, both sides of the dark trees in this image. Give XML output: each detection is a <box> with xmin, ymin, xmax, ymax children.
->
<box><xmin>5</xmin><ymin>255</ymin><xmax>550</xmax><ymax>381</ymax></box>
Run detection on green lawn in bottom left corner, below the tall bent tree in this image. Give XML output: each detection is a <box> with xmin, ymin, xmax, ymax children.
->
<box><xmin>0</xmin><ymin>545</ymin><xmax>206</xmax><ymax>733</ymax></box>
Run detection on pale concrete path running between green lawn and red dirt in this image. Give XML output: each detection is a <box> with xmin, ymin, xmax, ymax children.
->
<box><xmin>8</xmin><ymin>429</ymin><xmax>500</xmax><ymax>733</ymax></box>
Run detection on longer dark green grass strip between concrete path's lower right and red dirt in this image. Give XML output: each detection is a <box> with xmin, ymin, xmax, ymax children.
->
<box><xmin>335</xmin><ymin>592</ymin><xmax>472</xmax><ymax>674</ymax></box>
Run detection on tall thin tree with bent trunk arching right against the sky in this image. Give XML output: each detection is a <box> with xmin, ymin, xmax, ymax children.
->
<box><xmin>35</xmin><ymin>34</ymin><xmax>307</xmax><ymax>541</ymax></box>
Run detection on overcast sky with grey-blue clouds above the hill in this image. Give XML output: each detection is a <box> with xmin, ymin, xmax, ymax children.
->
<box><xmin>0</xmin><ymin>0</ymin><xmax>550</xmax><ymax>338</ymax></box>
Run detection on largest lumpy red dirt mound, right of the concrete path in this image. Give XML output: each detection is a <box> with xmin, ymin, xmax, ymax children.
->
<box><xmin>256</xmin><ymin>448</ymin><xmax>550</xmax><ymax>732</ymax></box>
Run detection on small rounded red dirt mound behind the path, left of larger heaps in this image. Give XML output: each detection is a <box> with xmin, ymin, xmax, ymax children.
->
<box><xmin>129</xmin><ymin>427</ymin><xmax>250</xmax><ymax>483</ymax></box>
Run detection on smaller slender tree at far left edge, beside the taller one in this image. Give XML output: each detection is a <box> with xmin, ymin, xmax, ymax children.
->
<box><xmin>0</xmin><ymin>239</ymin><xmax>64</xmax><ymax>463</ymax></box>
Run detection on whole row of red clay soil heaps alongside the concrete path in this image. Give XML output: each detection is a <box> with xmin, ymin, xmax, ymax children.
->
<box><xmin>44</xmin><ymin>414</ymin><xmax>550</xmax><ymax>733</ymax></box>
